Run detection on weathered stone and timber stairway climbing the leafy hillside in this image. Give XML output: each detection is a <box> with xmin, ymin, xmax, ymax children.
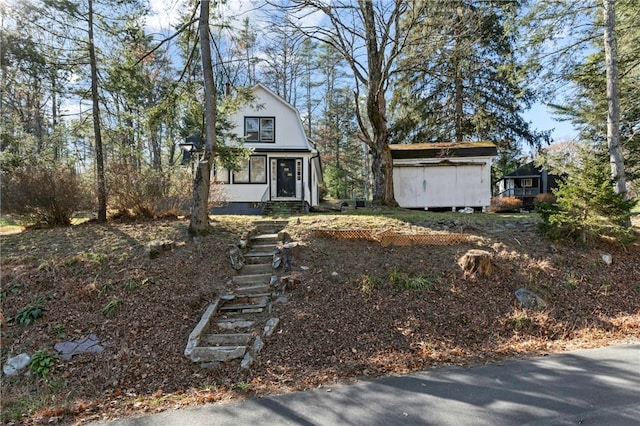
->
<box><xmin>185</xmin><ymin>220</ymin><xmax>287</xmax><ymax>368</ymax></box>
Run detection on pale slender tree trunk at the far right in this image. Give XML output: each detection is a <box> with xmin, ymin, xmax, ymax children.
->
<box><xmin>604</xmin><ymin>0</ymin><xmax>627</xmax><ymax>200</ymax></box>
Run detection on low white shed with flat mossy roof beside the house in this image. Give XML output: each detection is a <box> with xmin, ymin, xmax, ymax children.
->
<box><xmin>390</xmin><ymin>142</ymin><xmax>498</xmax><ymax>211</ymax></box>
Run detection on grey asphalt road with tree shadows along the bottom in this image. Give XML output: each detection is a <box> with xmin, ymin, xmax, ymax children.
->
<box><xmin>100</xmin><ymin>344</ymin><xmax>640</xmax><ymax>426</ymax></box>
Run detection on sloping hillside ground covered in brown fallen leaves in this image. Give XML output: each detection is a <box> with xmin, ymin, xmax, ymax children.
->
<box><xmin>0</xmin><ymin>212</ymin><xmax>640</xmax><ymax>424</ymax></box>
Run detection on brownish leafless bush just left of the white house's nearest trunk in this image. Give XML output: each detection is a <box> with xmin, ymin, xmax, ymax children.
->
<box><xmin>106</xmin><ymin>161</ymin><xmax>192</xmax><ymax>218</ymax></box>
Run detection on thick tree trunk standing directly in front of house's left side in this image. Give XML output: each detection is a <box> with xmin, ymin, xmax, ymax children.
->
<box><xmin>189</xmin><ymin>0</ymin><xmax>216</xmax><ymax>235</ymax></box>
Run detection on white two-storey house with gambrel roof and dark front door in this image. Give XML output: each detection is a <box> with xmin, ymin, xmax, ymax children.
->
<box><xmin>214</xmin><ymin>84</ymin><xmax>322</xmax><ymax>214</ymax></box>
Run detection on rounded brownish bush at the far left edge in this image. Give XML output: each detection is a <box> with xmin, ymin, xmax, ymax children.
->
<box><xmin>1</xmin><ymin>165</ymin><xmax>91</xmax><ymax>227</ymax></box>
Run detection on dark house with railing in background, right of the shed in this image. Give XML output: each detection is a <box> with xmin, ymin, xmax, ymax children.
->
<box><xmin>496</xmin><ymin>162</ymin><xmax>558</xmax><ymax>207</ymax></box>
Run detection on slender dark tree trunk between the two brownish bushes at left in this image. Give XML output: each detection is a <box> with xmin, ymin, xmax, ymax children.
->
<box><xmin>89</xmin><ymin>0</ymin><xmax>107</xmax><ymax>223</ymax></box>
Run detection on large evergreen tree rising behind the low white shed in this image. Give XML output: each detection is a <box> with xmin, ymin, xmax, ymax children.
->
<box><xmin>392</xmin><ymin>0</ymin><xmax>548</xmax><ymax>156</ymax></box>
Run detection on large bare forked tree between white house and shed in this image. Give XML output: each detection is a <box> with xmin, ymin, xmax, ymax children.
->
<box><xmin>282</xmin><ymin>0</ymin><xmax>422</xmax><ymax>206</ymax></box>
